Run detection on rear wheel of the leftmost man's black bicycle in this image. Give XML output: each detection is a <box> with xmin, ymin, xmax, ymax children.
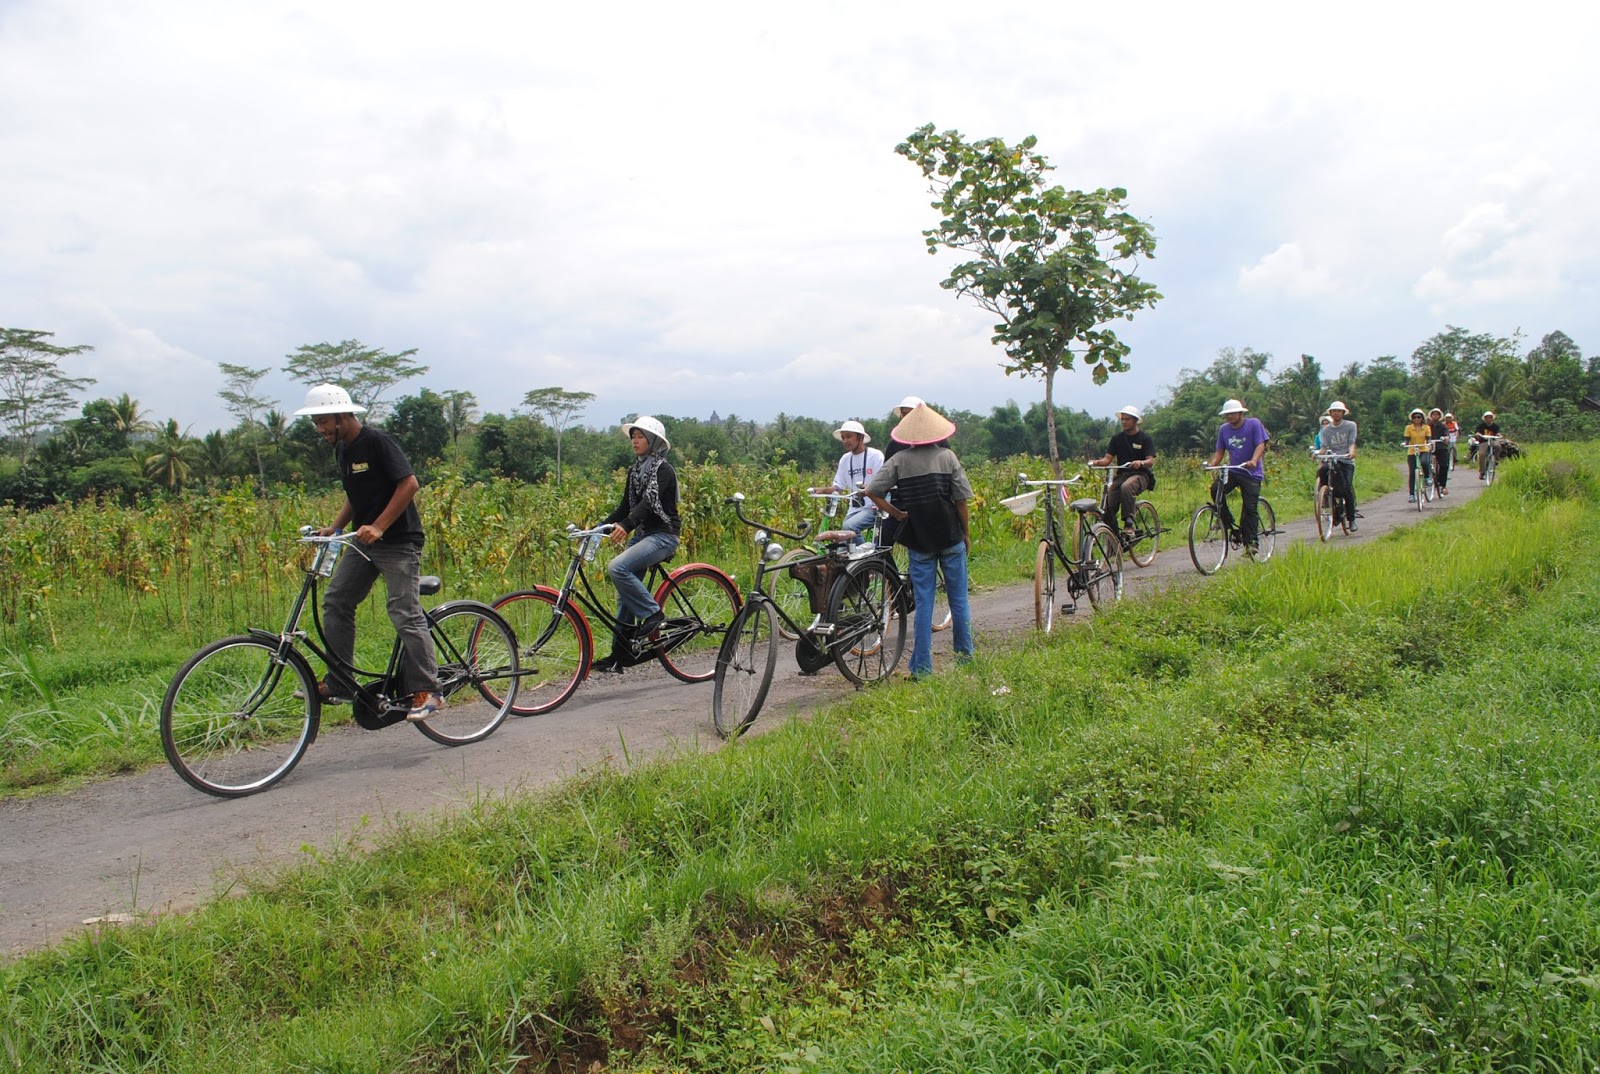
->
<box><xmin>413</xmin><ymin>600</ymin><xmax>520</xmax><ymax>746</ymax></box>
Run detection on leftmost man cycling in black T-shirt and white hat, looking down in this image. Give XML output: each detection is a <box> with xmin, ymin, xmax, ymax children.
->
<box><xmin>294</xmin><ymin>384</ymin><xmax>442</xmax><ymax>720</ymax></box>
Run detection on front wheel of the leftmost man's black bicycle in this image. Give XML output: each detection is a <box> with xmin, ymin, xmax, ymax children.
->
<box><xmin>162</xmin><ymin>635</ymin><xmax>322</xmax><ymax>799</ymax></box>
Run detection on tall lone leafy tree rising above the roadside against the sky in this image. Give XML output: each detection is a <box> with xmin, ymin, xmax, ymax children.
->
<box><xmin>894</xmin><ymin>123</ymin><xmax>1162</xmax><ymax>477</ymax></box>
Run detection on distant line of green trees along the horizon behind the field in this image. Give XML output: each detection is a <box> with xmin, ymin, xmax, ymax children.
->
<box><xmin>0</xmin><ymin>327</ymin><xmax>1600</xmax><ymax>507</ymax></box>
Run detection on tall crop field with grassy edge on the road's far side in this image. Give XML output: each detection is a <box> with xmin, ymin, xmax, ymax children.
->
<box><xmin>0</xmin><ymin>455</ymin><xmax>1395</xmax><ymax>797</ymax></box>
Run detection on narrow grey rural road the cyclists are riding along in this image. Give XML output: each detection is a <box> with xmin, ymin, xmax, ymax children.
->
<box><xmin>0</xmin><ymin>471</ymin><xmax>1482</xmax><ymax>957</ymax></box>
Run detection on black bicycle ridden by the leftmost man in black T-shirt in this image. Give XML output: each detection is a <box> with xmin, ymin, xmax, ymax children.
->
<box><xmin>162</xmin><ymin>527</ymin><xmax>520</xmax><ymax>797</ymax></box>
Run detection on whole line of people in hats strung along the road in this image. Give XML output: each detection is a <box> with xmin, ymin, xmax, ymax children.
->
<box><xmin>294</xmin><ymin>377</ymin><xmax>1499</xmax><ymax>704</ymax></box>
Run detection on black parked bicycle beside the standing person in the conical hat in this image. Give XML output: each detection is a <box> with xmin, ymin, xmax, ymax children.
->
<box><xmin>710</xmin><ymin>493</ymin><xmax>910</xmax><ymax>738</ymax></box>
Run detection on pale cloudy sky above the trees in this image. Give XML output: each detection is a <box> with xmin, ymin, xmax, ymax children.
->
<box><xmin>0</xmin><ymin>0</ymin><xmax>1600</xmax><ymax>434</ymax></box>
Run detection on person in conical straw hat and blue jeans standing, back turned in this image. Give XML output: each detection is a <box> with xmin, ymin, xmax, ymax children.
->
<box><xmin>867</xmin><ymin>403</ymin><xmax>973</xmax><ymax>679</ymax></box>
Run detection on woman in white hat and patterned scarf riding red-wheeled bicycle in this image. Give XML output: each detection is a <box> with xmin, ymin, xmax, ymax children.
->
<box><xmin>594</xmin><ymin>415</ymin><xmax>683</xmax><ymax>671</ymax></box>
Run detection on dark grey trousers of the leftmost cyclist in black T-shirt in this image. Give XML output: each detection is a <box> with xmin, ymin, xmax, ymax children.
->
<box><xmin>322</xmin><ymin>541</ymin><xmax>438</xmax><ymax>693</ymax></box>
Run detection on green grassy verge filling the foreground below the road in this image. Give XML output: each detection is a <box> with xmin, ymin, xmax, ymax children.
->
<box><xmin>0</xmin><ymin>448</ymin><xmax>1580</xmax><ymax>1074</ymax></box>
